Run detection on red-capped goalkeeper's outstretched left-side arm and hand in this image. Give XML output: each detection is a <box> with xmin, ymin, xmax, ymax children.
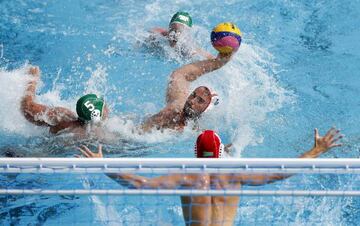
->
<box><xmin>78</xmin><ymin>145</ymin><xmax>201</xmax><ymax>189</ymax></box>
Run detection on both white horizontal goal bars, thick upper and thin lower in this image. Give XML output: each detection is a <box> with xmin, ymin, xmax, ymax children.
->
<box><xmin>0</xmin><ymin>158</ymin><xmax>360</xmax><ymax>197</ymax></box>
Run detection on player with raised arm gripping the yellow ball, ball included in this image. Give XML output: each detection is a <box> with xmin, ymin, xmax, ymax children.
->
<box><xmin>142</xmin><ymin>23</ymin><xmax>241</xmax><ymax>131</ymax></box>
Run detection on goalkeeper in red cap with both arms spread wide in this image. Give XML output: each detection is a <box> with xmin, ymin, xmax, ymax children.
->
<box><xmin>79</xmin><ymin>128</ymin><xmax>342</xmax><ymax>226</ymax></box>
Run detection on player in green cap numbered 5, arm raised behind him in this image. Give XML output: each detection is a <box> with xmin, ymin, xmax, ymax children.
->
<box><xmin>21</xmin><ymin>67</ymin><xmax>108</xmax><ymax>135</ymax></box>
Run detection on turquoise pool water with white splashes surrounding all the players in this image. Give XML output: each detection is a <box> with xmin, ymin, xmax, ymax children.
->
<box><xmin>0</xmin><ymin>0</ymin><xmax>360</xmax><ymax>225</ymax></box>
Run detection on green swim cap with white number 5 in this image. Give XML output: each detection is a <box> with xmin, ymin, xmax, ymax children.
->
<box><xmin>76</xmin><ymin>94</ymin><xmax>105</xmax><ymax>122</ymax></box>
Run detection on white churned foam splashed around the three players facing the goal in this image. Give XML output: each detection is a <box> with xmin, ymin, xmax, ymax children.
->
<box><xmin>0</xmin><ymin>2</ymin><xmax>293</xmax><ymax>156</ymax></box>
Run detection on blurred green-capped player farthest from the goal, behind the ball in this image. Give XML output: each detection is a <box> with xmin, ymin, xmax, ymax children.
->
<box><xmin>146</xmin><ymin>12</ymin><xmax>215</xmax><ymax>59</ymax></box>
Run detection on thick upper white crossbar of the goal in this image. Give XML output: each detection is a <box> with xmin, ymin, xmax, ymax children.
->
<box><xmin>0</xmin><ymin>158</ymin><xmax>360</xmax><ymax>174</ymax></box>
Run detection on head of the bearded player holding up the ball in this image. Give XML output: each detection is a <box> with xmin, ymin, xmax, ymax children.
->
<box><xmin>183</xmin><ymin>86</ymin><xmax>219</xmax><ymax>119</ymax></box>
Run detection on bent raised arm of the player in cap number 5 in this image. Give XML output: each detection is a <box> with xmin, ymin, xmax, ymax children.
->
<box><xmin>21</xmin><ymin>67</ymin><xmax>77</xmax><ymax>127</ymax></box>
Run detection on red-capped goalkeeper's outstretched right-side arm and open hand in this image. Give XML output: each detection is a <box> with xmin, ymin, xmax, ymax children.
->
<box><xmin>233</xmin><ymin>128</ymin><xmax>343</xmax><ymax>186</ymax></box>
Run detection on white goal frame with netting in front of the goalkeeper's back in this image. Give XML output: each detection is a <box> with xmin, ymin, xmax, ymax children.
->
<box><xmin>0</xmin><ymin>158</ymin><xmax>360</xmax><ymax>225</ymax></box>
